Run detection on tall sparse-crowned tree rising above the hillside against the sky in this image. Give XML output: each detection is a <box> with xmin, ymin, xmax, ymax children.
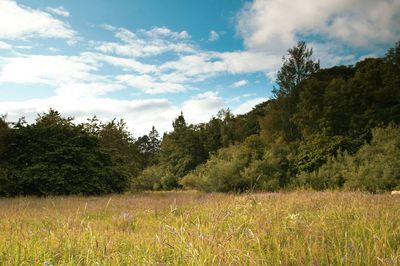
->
<box><xmin>273</xmin><ymin>42</ymin><xmax>319</xmax><ymax>97</ymax></box>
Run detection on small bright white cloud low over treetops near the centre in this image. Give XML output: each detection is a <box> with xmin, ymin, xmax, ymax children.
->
<box><xmin>182</xmin><ymin>91</ymin><xmax>224</xmax><ymax>123</ymax></box>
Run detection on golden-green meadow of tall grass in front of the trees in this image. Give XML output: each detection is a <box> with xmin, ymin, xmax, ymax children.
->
<box><xmin>0</xmin><ymin>192</ymin><xmax>400</xmax><ymax>265</ymax></box>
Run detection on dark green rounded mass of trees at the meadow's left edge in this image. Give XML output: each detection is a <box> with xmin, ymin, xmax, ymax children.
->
<box><xmin>0</xmin><ymin>110</ymin><xmax>128</xmax><ymax>196</ymax></box>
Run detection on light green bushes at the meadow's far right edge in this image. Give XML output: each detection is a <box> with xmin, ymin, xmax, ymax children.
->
<box><xmin>297</xmin><ymin>124</ymin><xmax>400</xmax><ymax>192</ymax></box>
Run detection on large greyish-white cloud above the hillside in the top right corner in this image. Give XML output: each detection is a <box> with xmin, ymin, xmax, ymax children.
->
<box><xmin>237</xmin><ymin>0</ymin><xmax>400</xmax><ymax>55</ymax></box>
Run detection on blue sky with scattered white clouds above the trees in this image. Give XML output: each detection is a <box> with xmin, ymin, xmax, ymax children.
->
<box><xmin>0</xmin><ymin>0</ymin><xmax>400</xmax><ymax>137</ymax></box>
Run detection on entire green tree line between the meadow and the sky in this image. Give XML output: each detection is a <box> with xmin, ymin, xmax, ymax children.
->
<box><xmin>0</xmin><ymin>42</ymin><xmax>400</xmax><ymax>196</ymax></box>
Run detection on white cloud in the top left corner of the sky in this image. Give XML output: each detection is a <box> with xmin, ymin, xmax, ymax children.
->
<box><xmin>0</xmin><ymin>0</ymin><xmax>76</xmax><ymax>40</ymax></box>
